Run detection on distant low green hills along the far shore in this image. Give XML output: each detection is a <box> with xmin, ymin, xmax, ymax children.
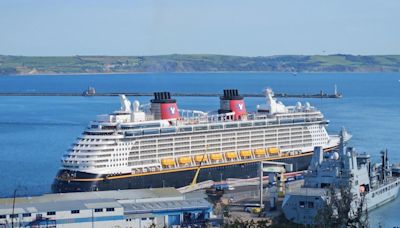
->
<box><xmin>0</xmin><ymin>54</ymin><xmax>400</xmax><ymax>75</ymax></box>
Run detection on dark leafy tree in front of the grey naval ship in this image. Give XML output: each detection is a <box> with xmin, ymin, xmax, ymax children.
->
<box><xmin>315</xmin><ymin>185</ymin><xmax>369</xmax><ymax>228</ymax></box>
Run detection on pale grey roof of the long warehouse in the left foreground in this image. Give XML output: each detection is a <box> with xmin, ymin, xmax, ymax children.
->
<box><xmin>0</xmin><ymin>188</ymin><xmax>210</xmax><ymax>214</ymax></box>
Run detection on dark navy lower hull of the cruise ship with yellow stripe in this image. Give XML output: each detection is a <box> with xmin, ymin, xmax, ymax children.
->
<box><xmin>52</xmin><ymin>148</ymin><xmax>333</xmax><ymax>193</ymax></box>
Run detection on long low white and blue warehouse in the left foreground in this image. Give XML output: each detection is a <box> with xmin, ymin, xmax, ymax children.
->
<box><xmin>0</xmin><ymin>188</ymin><xmax>212</xmax><ymax>228</ymax></box>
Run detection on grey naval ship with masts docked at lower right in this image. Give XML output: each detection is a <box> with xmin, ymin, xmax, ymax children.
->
<box><xmin>282</xmin><ymin>131</ymin><xmax>400</xmax><ymax>225</ymax></box>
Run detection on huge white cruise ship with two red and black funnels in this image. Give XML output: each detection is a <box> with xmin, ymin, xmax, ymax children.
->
<box><xmin>52</xmin><ymin>88</ymin><xmax>340</xmax><ymax>192</ymax></box>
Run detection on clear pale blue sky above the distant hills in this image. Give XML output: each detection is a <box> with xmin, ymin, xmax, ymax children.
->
<box><xmin>0</xmin><ymin>0</ymin><xmax>400</xmax><ymax>56</ymax></box>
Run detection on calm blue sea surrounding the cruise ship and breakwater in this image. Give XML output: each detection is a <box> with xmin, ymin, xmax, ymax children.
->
<box><xmin>0</xmin><ymin>73</ymin><xmax>400</xmax><ymax>227</ymax></box>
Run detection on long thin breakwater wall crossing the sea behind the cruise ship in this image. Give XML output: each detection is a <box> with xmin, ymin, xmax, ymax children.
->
<box><xmin>0</xmin><ymin>91</ymin><xmax>342</xmax><ymax>98</ymax></box>
